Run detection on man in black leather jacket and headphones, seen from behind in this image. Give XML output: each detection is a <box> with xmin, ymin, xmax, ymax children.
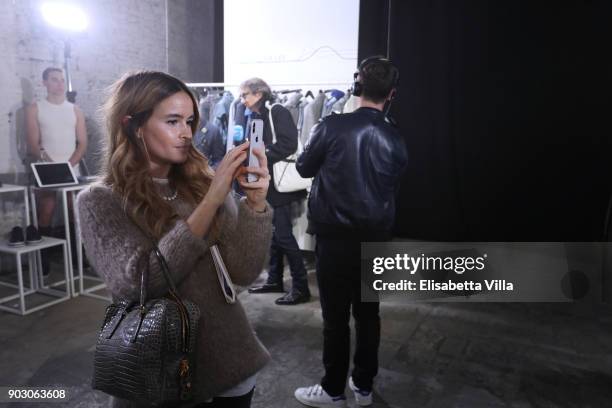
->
<box><xmin>295</xmin><ymin>57</ymin><xmax>407</xmax><ymax>406</ymax></box>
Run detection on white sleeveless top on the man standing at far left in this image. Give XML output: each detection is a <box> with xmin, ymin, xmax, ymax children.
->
<box><xmin>37</xmin><ymin>99</ymin><xmax>76</xmax><ymax>161</ymax></box>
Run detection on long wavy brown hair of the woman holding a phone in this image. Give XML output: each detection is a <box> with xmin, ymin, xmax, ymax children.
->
<box><xmin>102</xmin><ymin>71</ymin><xmax>214</xmax><ymax>239</ymax></box>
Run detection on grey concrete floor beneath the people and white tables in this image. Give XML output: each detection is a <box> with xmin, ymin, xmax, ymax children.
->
<box><xmin>0</xmin><ymin>255</ymin><xmax>612</xmax><ymax>408</ymax></box>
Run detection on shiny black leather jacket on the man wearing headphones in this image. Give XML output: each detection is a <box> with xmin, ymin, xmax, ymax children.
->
<box><xmin>297</xmin><ymin>108</ymin><xmax>408</xmax><ymax>239</ymax></box>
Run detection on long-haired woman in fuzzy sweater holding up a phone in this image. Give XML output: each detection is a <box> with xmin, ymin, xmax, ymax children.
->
<box><xmin>78</xmin><ymin>71</ymin><xmax>272</xmax><ymax>407</ymax></box>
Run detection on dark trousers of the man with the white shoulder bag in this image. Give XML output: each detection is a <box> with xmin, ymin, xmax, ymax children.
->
<box><xmin>268</xmin><ymin>203</ymin><xmax>309</xmax><ymax>293</ymax></box>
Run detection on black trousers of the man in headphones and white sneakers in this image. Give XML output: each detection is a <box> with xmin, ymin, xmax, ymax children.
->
<box><xmin>316</xmin><ymin>235</ymin><xmax>380</xmax><ymax>396</ymax></box>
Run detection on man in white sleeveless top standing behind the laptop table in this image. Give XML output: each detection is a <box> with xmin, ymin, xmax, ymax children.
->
<box><xmin>26</xmin><ymin>67</ymin><xmax>87</xmax><ymax>271</ymax></box>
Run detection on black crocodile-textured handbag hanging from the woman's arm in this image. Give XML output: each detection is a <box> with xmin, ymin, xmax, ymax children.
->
<box><xmin>92</xmin><ymin>246</ymin><xmax>200</xmax><ymax>407</ymax></box>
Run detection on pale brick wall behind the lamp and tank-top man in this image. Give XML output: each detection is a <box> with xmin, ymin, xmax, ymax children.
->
<box><xmin>0</xmin><ymin>0</ymin><xmax>218</xmax><ymax>178</ymax></box>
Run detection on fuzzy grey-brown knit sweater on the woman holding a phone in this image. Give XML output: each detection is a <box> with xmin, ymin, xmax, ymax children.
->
<box><xmin>77</xmin><ymin>184</ymin><xmax>272</xmax><ymax>402</ymax></box>
